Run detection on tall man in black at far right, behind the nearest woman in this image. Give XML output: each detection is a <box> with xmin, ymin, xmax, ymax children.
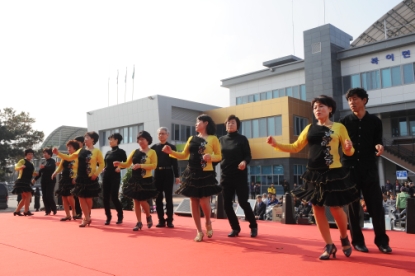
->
<box><xmin>340</xmin><ymin>88</ymin><xmax>392</xmax><ymax>253</ymax></box>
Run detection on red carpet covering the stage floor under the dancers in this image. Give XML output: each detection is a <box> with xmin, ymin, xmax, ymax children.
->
<box><xmin>0</xmin><ymin>209</ymin><xmax>415</xmax><ymax>276</ymax></box>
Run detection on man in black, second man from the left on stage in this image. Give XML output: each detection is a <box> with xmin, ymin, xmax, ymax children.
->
<box><xmin>102</xmin><ymin>133</ymin><xmax>127</xmax><ymax>225</ymax></box>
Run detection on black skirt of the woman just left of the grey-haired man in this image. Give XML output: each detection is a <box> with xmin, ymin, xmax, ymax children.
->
<box><xmin>122</xmin><ymin>176</ymin><xmax>158</xmax><ymax>201</ymax></box>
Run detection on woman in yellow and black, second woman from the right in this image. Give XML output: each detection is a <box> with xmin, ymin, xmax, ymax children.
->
<box><xmin>163</xmin><ymin>114</ymin><xmax>222</xmax><ymax>242</ymax></box>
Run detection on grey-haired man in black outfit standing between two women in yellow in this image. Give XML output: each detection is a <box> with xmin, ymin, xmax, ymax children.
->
<box><xmin>151</xmin><ymin>127</ymin><xmax>180</xmax><ymax>228</ymax></box>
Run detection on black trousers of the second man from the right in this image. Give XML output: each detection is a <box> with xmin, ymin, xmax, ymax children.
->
<box><xmin>221</xmin><ymin>174</ymin><xmax>258</xmax><ymax>230</ymax></box>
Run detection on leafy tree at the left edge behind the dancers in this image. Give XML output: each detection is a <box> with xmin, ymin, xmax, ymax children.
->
<box><xmin>0</xmin><ymin>108</ymin><xmax>45</xmax><ymax>180</ymax></box>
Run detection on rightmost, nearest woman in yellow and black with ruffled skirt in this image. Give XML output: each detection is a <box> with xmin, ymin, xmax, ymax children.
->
<box><xmin>267</xmin><ymin>95</ymin><xmax>359</xmax><ymax>260</ymax></box>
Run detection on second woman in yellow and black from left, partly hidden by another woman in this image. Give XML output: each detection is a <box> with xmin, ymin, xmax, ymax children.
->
<box><xmin>52</xmin><ymin>140</ymin><xmax>79</xmax><ymax>221</ymax></box>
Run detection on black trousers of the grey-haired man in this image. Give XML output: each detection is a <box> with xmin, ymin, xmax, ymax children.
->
<box><xmin>154</xmin><ymin>169</ymin><xmax>174</xmax><ymax>222</ymax></box>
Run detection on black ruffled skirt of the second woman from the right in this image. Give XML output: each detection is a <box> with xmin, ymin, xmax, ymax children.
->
<box><xmin>176</xmin><ymin>167</ymin><xmax>222</xmax><ymax>198</ymax></box>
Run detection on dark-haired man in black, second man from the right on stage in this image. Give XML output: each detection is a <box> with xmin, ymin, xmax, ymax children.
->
<box><xmin>219</xmin><ymin>115</ymin><xmax>258</xmax><ymax>237</ymax></box>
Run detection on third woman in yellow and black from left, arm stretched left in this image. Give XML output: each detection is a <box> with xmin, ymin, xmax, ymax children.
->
<box><xmin>53</xmin><ymin>131</ymin><xmax>105</xmax><ymax>227</ymax></box>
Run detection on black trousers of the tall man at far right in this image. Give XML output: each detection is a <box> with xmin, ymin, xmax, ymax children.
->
<box><xmin>349</xmin><ymin>166</ymin><xmax>389</xmax><ymax>245</ymax></box>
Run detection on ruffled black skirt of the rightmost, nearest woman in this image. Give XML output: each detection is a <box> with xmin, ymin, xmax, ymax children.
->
<box><xmin>291</xmin><ymin>168</ymin><xmax>359</xmax><ymax>207</ymax></box>
